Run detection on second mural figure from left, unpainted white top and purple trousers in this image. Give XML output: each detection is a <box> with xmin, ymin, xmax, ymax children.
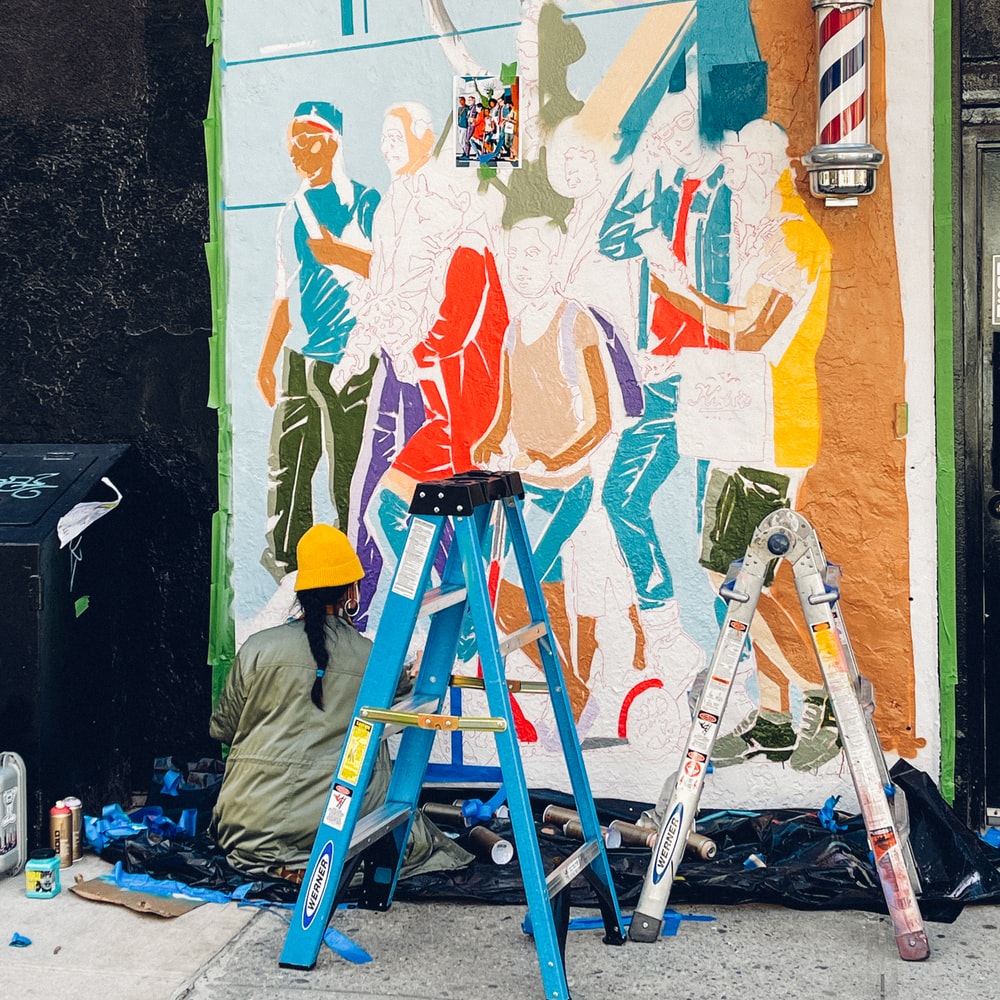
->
<box><xmin>348</xmin><ymin>101</ymin><xmax>439</xmax><ymax>629</ymax></box>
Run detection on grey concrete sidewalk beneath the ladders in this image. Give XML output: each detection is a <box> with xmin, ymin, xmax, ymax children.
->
<box><xmin>0</xmin><ymin>855</ymin><xmax>1000</xmax><ymax>1000</ymax></box>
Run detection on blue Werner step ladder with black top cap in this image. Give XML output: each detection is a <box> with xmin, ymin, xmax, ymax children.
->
<box><xmin>280</xmin><ymin>472</ymin><xmax>625</xmax><ymax>1000</ymax></box>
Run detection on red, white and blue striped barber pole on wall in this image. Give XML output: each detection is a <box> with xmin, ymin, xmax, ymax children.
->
<box><xmin>802</xmin><ymin>0</ymin><xmax>884</xmax><ymax>205</ymax></box>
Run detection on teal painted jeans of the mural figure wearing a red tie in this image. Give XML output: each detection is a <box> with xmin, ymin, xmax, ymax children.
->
<box><xmin>601</xmin><ymin>375</ymin><xmax>680</xmax><ymax>610</ymax></box>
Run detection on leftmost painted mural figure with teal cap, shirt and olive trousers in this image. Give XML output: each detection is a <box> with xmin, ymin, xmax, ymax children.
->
<box><xmin>257</xmin><ymin>101</ymin><xmax>379</xmax><ymax>582</ymax></box>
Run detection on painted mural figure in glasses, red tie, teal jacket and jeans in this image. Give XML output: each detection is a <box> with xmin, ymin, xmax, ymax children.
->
<box><xmin>600</xmin><ymin>82</ymin><xmax>716</xmax><ymax>691</ymax></box>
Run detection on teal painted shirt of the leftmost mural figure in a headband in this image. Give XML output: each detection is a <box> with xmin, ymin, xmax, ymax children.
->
<box><xmin>292</xmin><ymin>181</ymin><xmax>379</xmax><ymax>365</ymax></box>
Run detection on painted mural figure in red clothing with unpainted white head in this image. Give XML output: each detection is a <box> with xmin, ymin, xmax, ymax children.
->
<box><xmin>367</xmin><ymin>172</ymin><xmax>507</xmax><ymax>616</ymax></box>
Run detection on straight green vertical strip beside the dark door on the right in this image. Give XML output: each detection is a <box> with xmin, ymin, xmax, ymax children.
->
<box><xmin>934</xmin><ymin>0</ymin><xmax>958</xmax><ymax>802</ymax></box>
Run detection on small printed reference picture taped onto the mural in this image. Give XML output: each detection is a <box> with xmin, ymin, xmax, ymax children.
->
<box><xmin>454</xmin><ymin>76</ymin><xmax>520</xmax><ymax>167</ymax></box>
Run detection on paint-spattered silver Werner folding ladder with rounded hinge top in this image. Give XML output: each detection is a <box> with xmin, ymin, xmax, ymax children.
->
<box><xmin>629</xmin><ymin>510</ymin><xmax>930</xmax><ymax>961</ymax></box>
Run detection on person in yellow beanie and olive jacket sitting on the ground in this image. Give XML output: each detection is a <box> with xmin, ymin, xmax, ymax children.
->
<box><xmin>209</xmin><ymin>524</ymin><xmax>472</xmax><ymax>882</ymax></box>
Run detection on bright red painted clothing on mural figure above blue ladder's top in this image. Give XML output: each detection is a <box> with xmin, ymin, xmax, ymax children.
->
<box><xmin>393</xmin><ymin>246</ymin><xmax>508</xmax><ymax>481</ymax></box>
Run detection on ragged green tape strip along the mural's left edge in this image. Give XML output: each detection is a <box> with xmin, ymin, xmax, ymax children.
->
<box><xmin>204</xmin><ymin>0</ymin><xmax>236</xmax><ymax>705</ymax></box>
